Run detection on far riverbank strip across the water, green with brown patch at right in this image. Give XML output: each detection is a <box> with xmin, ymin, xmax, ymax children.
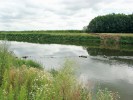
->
<box><xmin>0</xmin><ymin>31</ymin><xmax>133</xmax><ymax>45</ymax></box>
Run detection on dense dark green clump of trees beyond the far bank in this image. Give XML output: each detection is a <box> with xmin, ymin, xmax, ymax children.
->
<box><xmin>86</xmin><ymin>14</ymin><xmax>133</xmax><ymax>33</ymax></box>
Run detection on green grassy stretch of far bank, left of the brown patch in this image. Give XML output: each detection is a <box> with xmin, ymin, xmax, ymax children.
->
<box><xmin>0</xmin><ymin>32</ymin><xmax>100</xmax><ymax>44</ymax></box>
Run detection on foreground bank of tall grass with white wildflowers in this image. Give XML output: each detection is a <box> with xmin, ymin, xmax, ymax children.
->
<box><xmin>0</xmin><ymin>42</ymin><xmax>118</xmax><ymax>100</ymax></box>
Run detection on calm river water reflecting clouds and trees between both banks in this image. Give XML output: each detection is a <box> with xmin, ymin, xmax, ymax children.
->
<box><xmin>1</xmin><ymin>42</ymin><xmax>133</xmax><ymax>100</ymax></box>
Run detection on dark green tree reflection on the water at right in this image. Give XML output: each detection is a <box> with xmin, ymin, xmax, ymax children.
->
<box><xmin>87</xmin><ymin>47</ymin><xmax>133</xmax><ymax>67</ymax></box>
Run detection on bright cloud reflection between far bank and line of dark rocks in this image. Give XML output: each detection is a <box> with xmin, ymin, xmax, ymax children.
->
<box><xmin>10</xmin><ymin>42</ymin><xmax>88</xmax><ymax>57</ymax></box>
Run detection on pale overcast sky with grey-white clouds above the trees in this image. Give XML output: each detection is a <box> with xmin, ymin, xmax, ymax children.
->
<box><xmin>0</xmin><ymin>0</ymin><xmax>133</xmax><ymax>31</ymax></box>
